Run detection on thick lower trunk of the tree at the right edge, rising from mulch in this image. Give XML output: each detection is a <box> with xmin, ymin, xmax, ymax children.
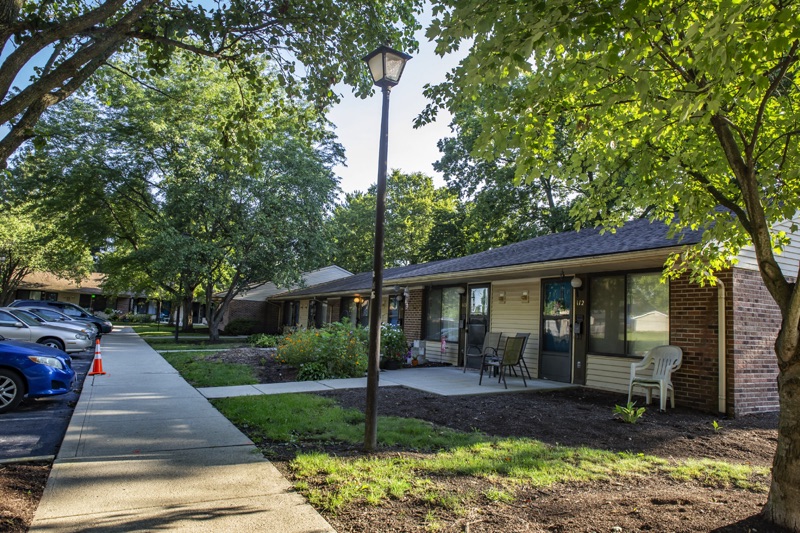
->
<box><xmin>764</xmin><ymin>362</ymin><xmax>800</xmax><ymax>531</ymax></box>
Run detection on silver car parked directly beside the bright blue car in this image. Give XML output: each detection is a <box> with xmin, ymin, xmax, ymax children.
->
<box><xmin>0</xmin><ymin>307</ymin><xmax>92</xmax><ymax>353</ymax></box>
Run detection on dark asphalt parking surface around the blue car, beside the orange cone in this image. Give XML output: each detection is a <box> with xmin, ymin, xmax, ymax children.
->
<box><xmin>0</xmin><ymin>351</ymin><xmax>94</xmax><ymax>462</ymax></box>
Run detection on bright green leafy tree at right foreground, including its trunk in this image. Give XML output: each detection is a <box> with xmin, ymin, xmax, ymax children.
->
<box><xmin>423</xmin><ymin>0</ymin><xmax>800</xmax><ymax>530</ymax></box>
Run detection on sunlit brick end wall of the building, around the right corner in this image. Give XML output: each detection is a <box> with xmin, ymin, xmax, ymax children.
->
<box><xmin>732</xmin><ymin>268</ymin><xmax>781</xmax><ymax>415</ymax></box>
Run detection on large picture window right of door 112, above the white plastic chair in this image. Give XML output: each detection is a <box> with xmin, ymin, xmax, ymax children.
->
<box><xmin>589</xmin><ymin>272</ymin><xmax>669</xmax><ymax>355</ymax></box>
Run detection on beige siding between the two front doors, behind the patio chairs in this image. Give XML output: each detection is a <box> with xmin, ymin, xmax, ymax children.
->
<box><xmin>490</xmin><ymin>279</ymin><xmax>541</xmax><ymax>378</ymax></box>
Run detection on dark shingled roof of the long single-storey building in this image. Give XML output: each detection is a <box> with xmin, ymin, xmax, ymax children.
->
<box><xmin>284</xmin><ymin>220</ymin><xmax>702</xmax><ymax>296</ymax></box>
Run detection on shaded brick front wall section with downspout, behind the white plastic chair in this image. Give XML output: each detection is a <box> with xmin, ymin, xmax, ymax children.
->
<box><xmin>669</xmin><ymin>271</ymin><xmax>733</xmax><ymax>412</ymax></box>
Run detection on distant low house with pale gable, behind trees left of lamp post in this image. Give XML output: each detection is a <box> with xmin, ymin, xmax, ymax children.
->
<box><xmin>220</xmin><ymin>265</ymin><xmax>353</xmax><ymax>333</ymax></box>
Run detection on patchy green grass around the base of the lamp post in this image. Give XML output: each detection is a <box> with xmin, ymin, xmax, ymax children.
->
<box><xmin>213</xmin><ymin>394</ymin><xmax>769</xmax><ymax>512</ymax></box>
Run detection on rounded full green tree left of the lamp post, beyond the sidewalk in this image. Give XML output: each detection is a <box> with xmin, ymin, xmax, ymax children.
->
<box><xmin>14</xmin><ymin>54</ymin><xmax>341</xmax><ymax>336</ymax></box>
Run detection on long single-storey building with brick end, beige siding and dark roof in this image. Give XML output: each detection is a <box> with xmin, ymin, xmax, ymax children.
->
<box><xmin>268</xmin><ymin>220</ymin><xmax>800</xmax><ymax>415</ymax></box>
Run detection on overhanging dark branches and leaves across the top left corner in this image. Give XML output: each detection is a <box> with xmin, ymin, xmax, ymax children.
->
<box><xmin>0</xmin><ymin>0</ymin><xmax>421</xmax><ymax>165</ymax></box>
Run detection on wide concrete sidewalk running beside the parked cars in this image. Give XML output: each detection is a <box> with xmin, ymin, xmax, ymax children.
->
<box><xmin>30</xmin><ymin>333</ymin><xmax>333</xmax><ymax>533</ymax></box>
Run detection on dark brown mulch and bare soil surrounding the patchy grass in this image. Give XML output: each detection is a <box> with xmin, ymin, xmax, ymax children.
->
<box><xmin>0</xmin><ymin>348</ymin><xmax>783</xmax><ymax>533</ymax></box>
